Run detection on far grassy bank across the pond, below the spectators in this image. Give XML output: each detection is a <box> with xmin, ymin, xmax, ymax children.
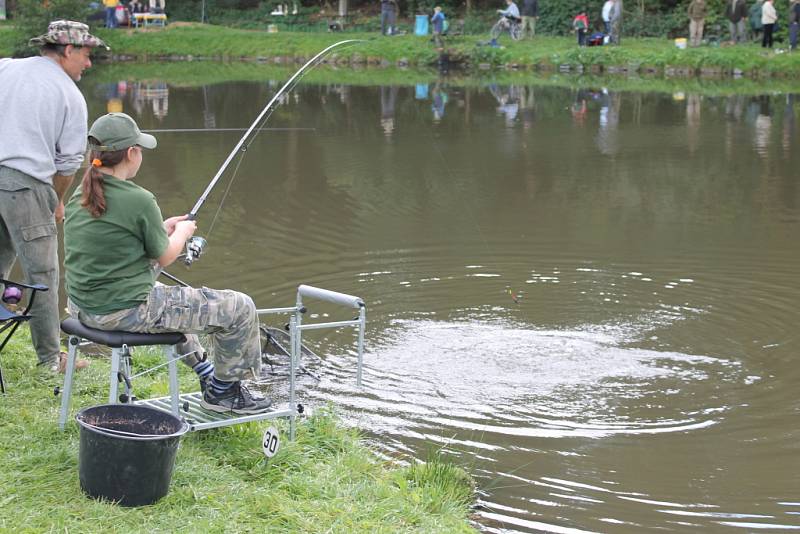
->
<box><xmin>0</xmin><ymin>23</ymin><xmax>800</xmax><ymax>78</ymax></box>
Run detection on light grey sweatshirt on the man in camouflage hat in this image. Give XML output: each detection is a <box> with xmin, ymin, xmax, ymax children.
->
<box><xmin>0</xmin><ymin>56</ymin><xmax>88</xmax><ymax>185</ymax></box>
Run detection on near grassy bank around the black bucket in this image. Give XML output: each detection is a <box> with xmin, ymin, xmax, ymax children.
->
<box><xmin>0</xmin><ymin>333</ymin><xmax>472</xmax><ymax>533</ymax></box>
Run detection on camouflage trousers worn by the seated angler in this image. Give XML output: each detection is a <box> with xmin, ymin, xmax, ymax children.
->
<box><xmin>68</xmin><ymin>282</ymin><xmax>261</xmax><ymax>381</ymax></box>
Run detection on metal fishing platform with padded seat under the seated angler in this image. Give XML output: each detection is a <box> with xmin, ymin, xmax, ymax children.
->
<box><xmin>59</xmin><ymin>285</ymin><xmax>366</xmax><ymax>439</ymax></box>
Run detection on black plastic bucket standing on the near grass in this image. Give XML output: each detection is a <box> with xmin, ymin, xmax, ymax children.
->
<box><xmin>75</xmin><ymin>404</ymin><xmax>189</xmax><ymax>506</ymax></box>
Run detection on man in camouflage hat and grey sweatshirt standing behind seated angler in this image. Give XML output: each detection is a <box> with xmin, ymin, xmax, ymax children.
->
<box><xmin>0</xmin><ymin>20</ymin><xmax>108</xmax><ymax>372</ymax></box>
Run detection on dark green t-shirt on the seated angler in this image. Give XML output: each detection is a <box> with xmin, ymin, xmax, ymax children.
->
<box><xmin>64</xmin><ymin>175</ymin><xmax>169</xmax><ymax>315</ymax></box>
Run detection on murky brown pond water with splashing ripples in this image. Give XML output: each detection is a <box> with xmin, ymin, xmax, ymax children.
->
<box><xmin>78</xmin><ymin>72</ymin><xmax>800</xmax><ymax>532</ymax></box>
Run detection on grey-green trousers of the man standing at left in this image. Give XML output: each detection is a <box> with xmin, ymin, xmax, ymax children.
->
<box><xmin>0</xmin><ymin>166</ymin><xmax>61</xmax><ymax>365</ymax></box>
